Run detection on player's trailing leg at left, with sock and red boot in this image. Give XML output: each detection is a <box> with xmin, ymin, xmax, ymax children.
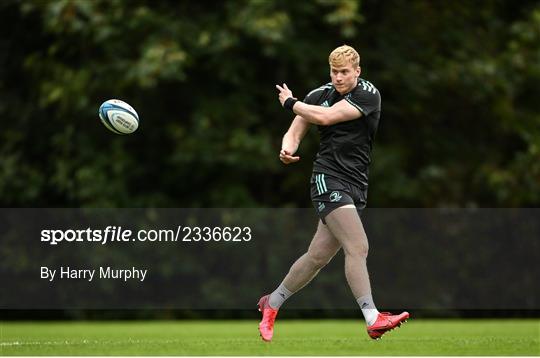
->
<box><xmin>259</xmin><ymin>222</ymin><xmax>341</xmax><ymax>341</ymax></box>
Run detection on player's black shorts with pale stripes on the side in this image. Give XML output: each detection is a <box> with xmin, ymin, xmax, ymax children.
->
<box><xmin>311</xmin><ymin>173</ymin><xmax>367</xmax><ymax>224</ymax></box>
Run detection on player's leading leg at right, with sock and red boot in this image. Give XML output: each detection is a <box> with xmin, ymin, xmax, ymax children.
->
<box><xmin>325</xmin><ymin>205</ymin><xmax>409</xmax><ymax>339</ymax></box>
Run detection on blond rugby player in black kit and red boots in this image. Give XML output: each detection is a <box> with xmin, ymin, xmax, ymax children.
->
<box><xmin>258</xmin><ymin>45</ymin><xmax>409</xmax><ymax>341</ymax></box>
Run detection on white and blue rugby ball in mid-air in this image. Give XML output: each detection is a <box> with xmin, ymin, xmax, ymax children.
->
<box><xmin>98</xmin><ymin>99</ymin><xmax>139</xmax><ymax>134</ymax></box>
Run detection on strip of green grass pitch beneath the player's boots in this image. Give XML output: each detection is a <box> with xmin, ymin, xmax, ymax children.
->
<box><xmin>0</xmin><ymin>319</ymin><xmax>540</xmax><ymax>356</ymax></box>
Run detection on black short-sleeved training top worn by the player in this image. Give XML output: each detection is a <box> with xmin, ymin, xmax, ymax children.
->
<box><xmin>304</xmin><ymin>78</ymin><xmax>381</xmax><ymax>188</ymax></box>
